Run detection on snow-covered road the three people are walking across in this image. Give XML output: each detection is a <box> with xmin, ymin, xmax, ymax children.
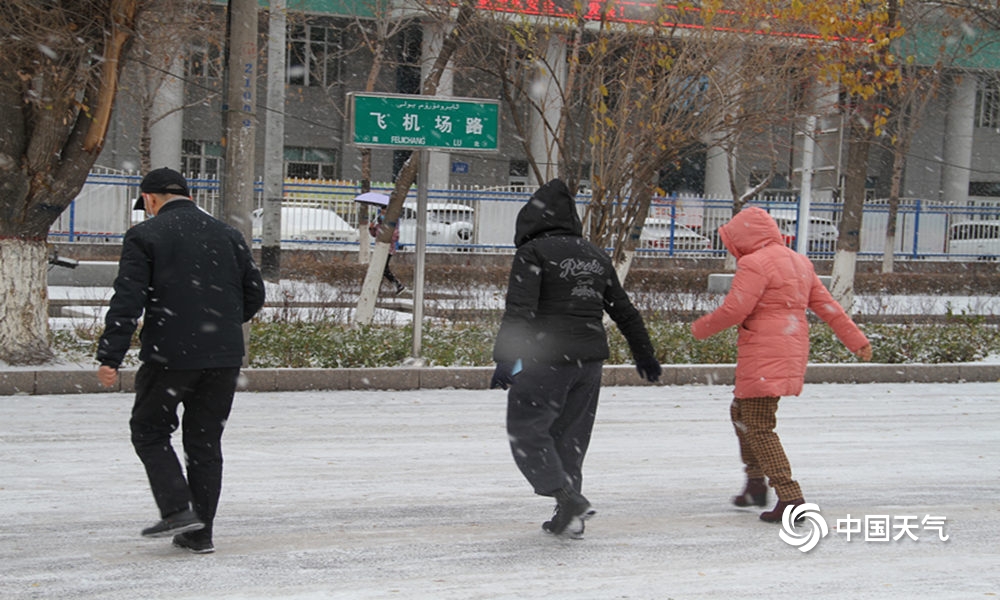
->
<box><xmin>0</xmin><ymin>383</ymin><xmax>1000</xmax><ymax>600</ymax></box>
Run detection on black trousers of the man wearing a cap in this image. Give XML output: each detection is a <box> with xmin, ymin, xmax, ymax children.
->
<box><xmin>129</xmin><ymin>365</ymin><xmax>240</xmax><ymax>535</ymax></box>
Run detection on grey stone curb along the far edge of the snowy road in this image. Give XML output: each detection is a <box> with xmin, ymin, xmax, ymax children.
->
<box><xmin>0</xmin><ymin>362</ymin><xmax>1000</xmax><ymax>396</ymax></box>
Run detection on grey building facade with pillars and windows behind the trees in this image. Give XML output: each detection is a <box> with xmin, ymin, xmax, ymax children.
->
<box><xmin>98</xmin><ymin>0</ymin><xmax>1000</xmax><ymax>211</ymax></box>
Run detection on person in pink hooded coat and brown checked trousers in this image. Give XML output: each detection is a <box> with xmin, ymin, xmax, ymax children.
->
<box><xmin>691</xmin><ymin>207</ymin><xmax>872</xmax><ymax>522</ymax></box>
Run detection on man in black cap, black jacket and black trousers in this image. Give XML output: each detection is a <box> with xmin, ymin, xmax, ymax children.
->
<box><xmin>97</xmin><ymin>168</ymin><xmax>264</xmax><ymax>554</ymax></box>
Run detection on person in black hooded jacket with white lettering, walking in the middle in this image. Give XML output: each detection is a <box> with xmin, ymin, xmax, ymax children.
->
<box><xmin>490</xmin><ymin>179</ymin><xmax>661</xmax><ymax>537</ymax></box>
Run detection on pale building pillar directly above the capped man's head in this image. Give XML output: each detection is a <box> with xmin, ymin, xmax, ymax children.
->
<box><xmin>149</xmin><ymin>56</ymin><xmax>184</xmax><ymax>171</ymax></box>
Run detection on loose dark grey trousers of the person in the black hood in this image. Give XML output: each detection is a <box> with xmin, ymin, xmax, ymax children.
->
<box><xmin>507</xmin><ymin>361</ymin><xmax>603</xmax><ymax>496</ymax></box>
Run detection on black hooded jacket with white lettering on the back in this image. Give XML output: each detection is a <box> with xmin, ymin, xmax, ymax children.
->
<box><xmin>493</xmin><ymin>179</ymin><xmax>653</xmax><ymax>364</ymax></box>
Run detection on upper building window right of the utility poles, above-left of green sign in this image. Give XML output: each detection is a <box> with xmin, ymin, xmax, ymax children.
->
<box><xmin>286</xmin><ymin>25</ymin><xmax>342</xmax><ymax>87</ymax></box>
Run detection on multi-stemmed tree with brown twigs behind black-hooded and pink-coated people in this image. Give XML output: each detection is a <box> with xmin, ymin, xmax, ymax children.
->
<box><xmin>460</xmin><ymin>3</ymin><xmax>801</xmax><ymax>276</ymax></box>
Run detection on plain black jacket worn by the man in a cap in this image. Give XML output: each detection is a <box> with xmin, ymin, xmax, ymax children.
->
<box><xmin>97</xmin><ymin>200</ymin><xmax>264</xmax><ymax>369</ymax></box>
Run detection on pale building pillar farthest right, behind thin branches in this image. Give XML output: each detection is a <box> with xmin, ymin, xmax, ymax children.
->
<box><xmin>941</xmin><ymin>73</ymin><xmax>977</xmax><ymax>206</ymax></box>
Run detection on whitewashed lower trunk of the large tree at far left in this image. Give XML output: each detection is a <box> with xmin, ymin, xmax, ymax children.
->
<box><xmin>0</xmin><ymin>238</ymin><xmax>53</xmax><ymax>365</ymax></box>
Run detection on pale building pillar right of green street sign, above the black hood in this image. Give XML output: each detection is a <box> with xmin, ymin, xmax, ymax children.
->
<box><xmin>530</xmin><ymin>35</ymin><xmax>566</xmax><ymax>183</ymax></box>
